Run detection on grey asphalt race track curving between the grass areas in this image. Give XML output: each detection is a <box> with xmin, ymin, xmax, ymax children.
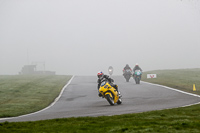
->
<box><xmin>0</xmin><ymin>76</ymin><xmax>200</xmax><ymax>122</ymax></box>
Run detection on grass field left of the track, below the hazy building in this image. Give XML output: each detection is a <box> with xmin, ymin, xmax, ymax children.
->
<box><xmin>0</xmin><ymin>75</ymin><xmax>71</xmax><ymax>117</ymax></box>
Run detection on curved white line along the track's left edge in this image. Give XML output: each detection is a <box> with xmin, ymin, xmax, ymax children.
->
<box><xmin>0</xmin><ymin>75</ymin><xmax>75</xmax><ymax>120</ymax></box>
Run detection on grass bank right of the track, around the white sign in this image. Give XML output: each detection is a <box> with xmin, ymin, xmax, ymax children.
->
<box><xmin>142</xmin><ymin>68</ymin><xmax>200</xmax><ymax>95</ymax></box>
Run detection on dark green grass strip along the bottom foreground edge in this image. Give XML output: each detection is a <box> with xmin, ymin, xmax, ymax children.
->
<box><xmin>0</xmin><ymin>105</ymin><xmax>200</xmax><ymax>133</ymax></box>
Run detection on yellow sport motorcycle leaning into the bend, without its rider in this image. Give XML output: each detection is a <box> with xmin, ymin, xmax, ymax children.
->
<box><xmin>99</xmin><ymin>80</ymin><xmax>122</xmax><ymax>105</ymax></box>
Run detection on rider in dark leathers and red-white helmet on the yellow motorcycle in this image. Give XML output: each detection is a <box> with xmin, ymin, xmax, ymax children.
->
<box><xmin>97</xmin><ymin>71</ymin><xmax>119</xmax><ymax>97</ymax></box>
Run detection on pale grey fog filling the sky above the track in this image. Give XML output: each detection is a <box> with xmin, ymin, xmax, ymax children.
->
<box><xmin>0</xmin><ymin>0</ymin><xmax>200</xmax><ymax>75</ymax></box>
